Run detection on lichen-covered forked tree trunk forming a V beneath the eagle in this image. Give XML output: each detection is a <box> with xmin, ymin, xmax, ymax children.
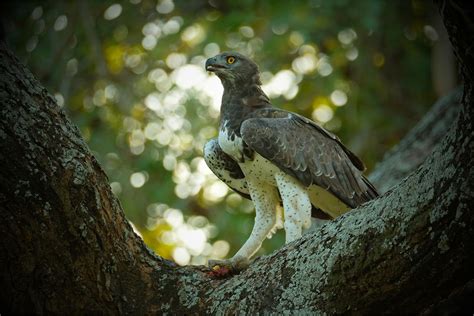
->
<box><xmin>0</xmin><ymin>1</ymin><xmax>474</xmax><ymax>314</ymax></box>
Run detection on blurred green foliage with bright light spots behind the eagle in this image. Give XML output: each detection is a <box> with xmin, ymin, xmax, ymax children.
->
<box><xmin>5</xmin><ymin>0</ymin><xmax>434</xmax><ymax>263</ymax></box>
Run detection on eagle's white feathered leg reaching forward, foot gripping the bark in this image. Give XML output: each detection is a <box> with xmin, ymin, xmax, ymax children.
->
<box><xmin>209</xmin><ymin>181</ymin><xmax>279</xmax><ymax>270</ymax></box>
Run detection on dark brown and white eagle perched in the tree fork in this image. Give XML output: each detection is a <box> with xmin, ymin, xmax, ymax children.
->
<box><xmin>204</xmin><ymin>52</ymin><xmax>378</xmax><ymax>270</ymax></box>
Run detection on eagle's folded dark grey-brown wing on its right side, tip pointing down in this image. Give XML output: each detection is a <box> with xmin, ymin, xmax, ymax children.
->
<box><xmin>240</xmin><ymin>108</ymin><xmax>378</xmax><ymax>208</ymax></box>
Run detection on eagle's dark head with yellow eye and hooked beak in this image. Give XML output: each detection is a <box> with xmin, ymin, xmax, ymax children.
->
<box><xmin>206</xmin><ymin>52</ymin><xmax>261</xmax><ymax>87</ymax></box>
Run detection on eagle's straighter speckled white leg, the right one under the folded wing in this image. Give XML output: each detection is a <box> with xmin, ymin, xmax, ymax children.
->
<box><xmin>275</xmin><ymin>173</ymin><xmax>311</xmax><ymax>243</ymax></box>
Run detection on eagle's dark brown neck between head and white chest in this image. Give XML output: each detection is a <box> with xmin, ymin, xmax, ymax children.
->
<box><xmin>220</xmin><ymin>80</ymin><xmax>272</xmax><ymax>137</ymax></box>
